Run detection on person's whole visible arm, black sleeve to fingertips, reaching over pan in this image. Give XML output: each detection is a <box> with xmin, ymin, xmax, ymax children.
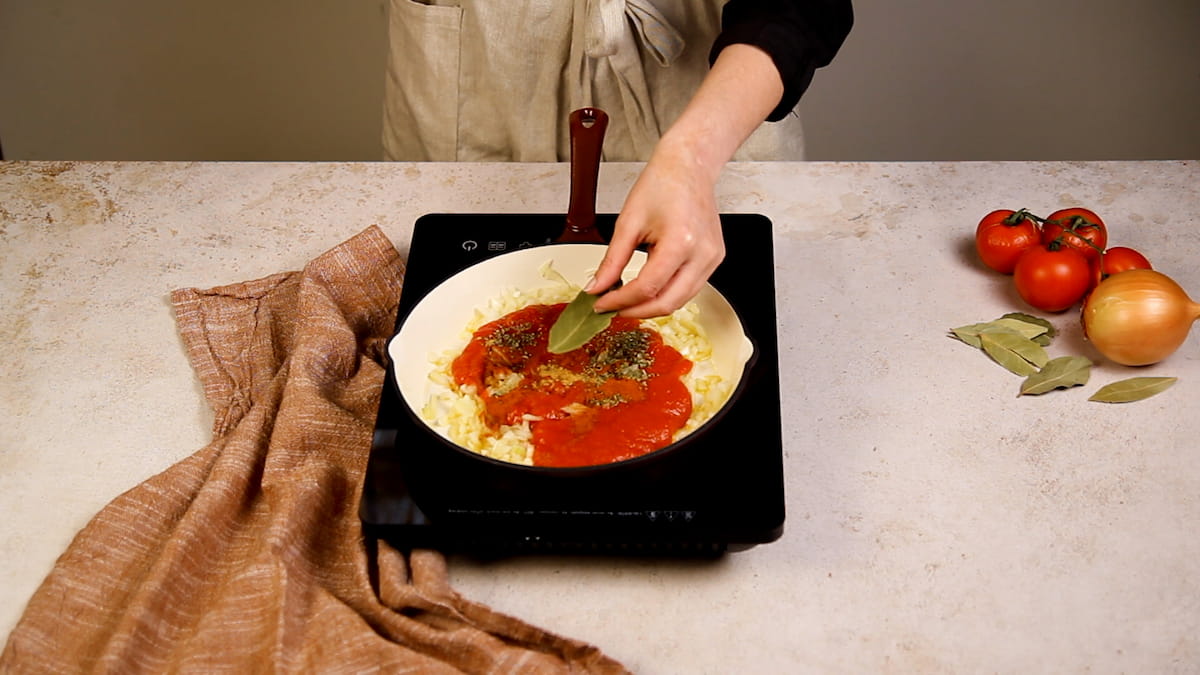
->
<box><xmin>587</xmin><ymin>0</ymin><xmax>852</xmax><ymax>318</ymax></box>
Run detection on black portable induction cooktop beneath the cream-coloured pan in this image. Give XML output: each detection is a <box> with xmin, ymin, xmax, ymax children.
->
<box><xmin>360</xmin><ymin>214</ymin><xmax>784</xmax><ymax>555</ymax></box>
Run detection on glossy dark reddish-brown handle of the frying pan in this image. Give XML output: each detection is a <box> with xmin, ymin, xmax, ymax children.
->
<box><xmin>558</xmin><ymin>108</ymin><xmax>608</xmax><ymax>244</ymax></box>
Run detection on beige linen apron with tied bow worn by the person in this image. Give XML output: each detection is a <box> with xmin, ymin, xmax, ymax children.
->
<box><xmin>383</xmin><ymin>0</ymin><xmax>804</xmax><ymax>162</ymax></box>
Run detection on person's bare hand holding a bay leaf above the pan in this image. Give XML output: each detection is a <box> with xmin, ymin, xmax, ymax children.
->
<box><xmin>584</xmin><ymin>145</ymin><xmax>725</xmax><ymax>318</ymax></box>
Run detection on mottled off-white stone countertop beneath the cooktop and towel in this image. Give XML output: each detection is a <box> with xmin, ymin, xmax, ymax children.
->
<box><xmin>0</xmin><ymin>161</ymin><xmax>1200</xmax><ymax>674</ymax></box>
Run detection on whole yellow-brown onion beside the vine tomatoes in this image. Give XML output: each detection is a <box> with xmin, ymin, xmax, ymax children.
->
<box><xmin>1082</xmin><ymin>269</ymin><xmax>1200</xmax><ymax>365</ymax></box>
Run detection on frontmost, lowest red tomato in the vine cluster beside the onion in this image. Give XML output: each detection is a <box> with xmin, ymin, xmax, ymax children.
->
<box><xmin>1013</xmin><ymin>244</ymin><xmax>1092</xmax><ymax>312</ymax></box>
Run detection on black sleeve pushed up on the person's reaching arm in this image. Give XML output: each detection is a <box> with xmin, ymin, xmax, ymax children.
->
<box><xmin>708</xmin><ymin>0</ymin><xmax>854</xmax><ymax>121</ymax></box>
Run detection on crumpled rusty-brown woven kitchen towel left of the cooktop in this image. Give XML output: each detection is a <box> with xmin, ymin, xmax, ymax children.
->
<box><xmin>0</xmin><ymin>227</ymin><xmax>624</xmax><ymax>673</ymax></box>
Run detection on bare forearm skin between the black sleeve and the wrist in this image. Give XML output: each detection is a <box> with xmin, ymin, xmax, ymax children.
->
<box><xmin>650</xmin><ymin>44</ymin><xmax>784</xmax><ymax>184</ymax></box>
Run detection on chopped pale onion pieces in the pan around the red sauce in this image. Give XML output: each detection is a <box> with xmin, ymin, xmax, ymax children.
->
<box><xmin>420</xmin><ymin>263</ymin><xmax>733</xmax><ymax>465</ymax></box>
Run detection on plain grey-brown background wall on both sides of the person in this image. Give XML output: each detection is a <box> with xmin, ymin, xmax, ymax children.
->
<box><xmin>0</xmin><ymin>0</ymin><xmax>1200</xmax><ymax>160</ymax></box>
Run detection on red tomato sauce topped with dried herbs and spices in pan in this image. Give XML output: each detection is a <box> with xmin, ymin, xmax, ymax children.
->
<box><xmin>451</xmin><ymin>303</ymin><xmax>692</xmax><ymax>466</ymax></box>
